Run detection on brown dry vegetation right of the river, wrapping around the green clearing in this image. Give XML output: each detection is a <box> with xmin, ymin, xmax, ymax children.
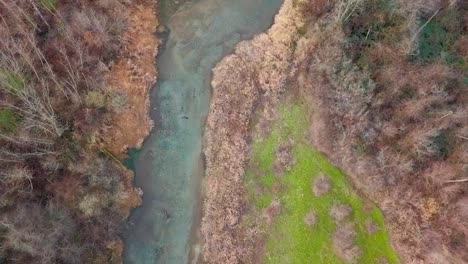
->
<box><xmin>202</xmin><ymin>0</ymin><xmax>468</xmax><ymax>264</ymax></box>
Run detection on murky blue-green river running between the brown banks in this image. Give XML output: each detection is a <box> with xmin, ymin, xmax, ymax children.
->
<box><xmin>124</xmin><ymin>0</ymin><xmax>282</xmax><ymax>264</ymax></box>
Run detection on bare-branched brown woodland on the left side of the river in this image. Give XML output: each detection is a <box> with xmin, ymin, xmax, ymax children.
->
<box><xmin>0</xmin><ymin>0</ymin><xmax>143</xmax><ymax>264</ymax></box>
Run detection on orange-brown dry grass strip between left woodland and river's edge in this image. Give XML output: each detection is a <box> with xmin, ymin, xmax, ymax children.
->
<box><xmin>102</xmin><ymin>2</ymin><xmax>158</xmax><ymax>157</ymax></box>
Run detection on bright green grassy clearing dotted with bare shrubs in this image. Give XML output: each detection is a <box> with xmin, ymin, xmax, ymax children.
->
<box><xmin>245</xmin><ymin>104</ymin><xmax>398</xmax><ymax>264</ymax></box>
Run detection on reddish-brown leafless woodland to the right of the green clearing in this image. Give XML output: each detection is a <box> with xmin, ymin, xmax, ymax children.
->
<box><xmin>296</xmin><ymin>0</ymin><xmax>468</xmax><ymax>264</ymax></box>
